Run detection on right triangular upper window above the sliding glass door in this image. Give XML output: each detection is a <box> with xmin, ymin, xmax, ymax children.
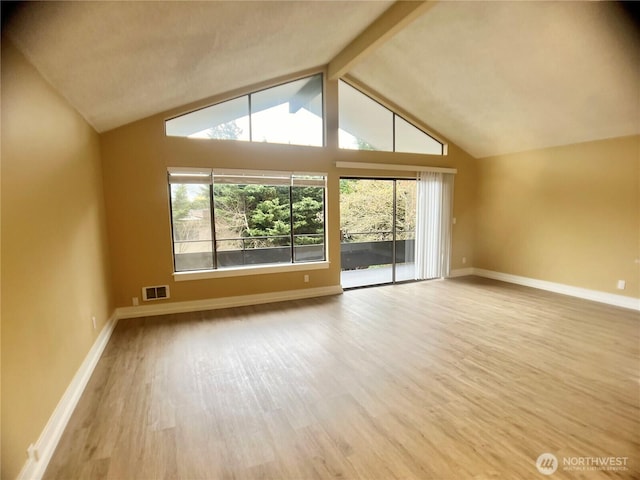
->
<box><xmin>338</xmin><ymin>80</ymin><xmax>443</xmax><ymax>155</ymax></box>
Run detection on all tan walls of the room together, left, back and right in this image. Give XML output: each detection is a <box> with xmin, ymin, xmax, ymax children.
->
<box><xmin>1</xmin><ymin>28</ymin><xmax>640</xmax><ymax>478</ymax></box>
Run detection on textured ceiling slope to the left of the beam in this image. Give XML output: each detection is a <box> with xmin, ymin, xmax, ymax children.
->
<box><xmin>6</xmin><ymin>1</ymin><xmax>393</xmax><ymax>132</ymax></box>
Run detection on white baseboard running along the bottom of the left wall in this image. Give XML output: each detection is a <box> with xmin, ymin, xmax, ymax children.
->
<box><xmin>18</xmin><ymin>315</ymin><xmax>118</xmax><ymax>480</ymax></box>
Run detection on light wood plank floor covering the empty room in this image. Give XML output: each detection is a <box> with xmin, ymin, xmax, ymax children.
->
<box><xmin>45</xmin><ymin>277</ymin><xmax>640</xmax><ymax>480</ymax></box>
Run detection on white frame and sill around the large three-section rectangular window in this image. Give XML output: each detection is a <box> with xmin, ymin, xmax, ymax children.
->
<box><xmin>167</xmin><ymin>167</ymin><xmax>329</xmax><ymax>281</ymax></box>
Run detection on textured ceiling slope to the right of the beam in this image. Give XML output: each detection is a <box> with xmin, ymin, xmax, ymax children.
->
<box><xmin>351</xmin><ymin>2</ymin><xmax>640</xmax><ymax>157</ymax></box>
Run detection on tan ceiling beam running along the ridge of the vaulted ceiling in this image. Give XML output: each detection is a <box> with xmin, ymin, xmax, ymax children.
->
<box><xmin>328</xmin><ymin>1</ymin><xmax>437</xmax><ymax>80</ymax></box>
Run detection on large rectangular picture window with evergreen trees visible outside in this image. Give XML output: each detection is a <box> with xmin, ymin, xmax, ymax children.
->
<box><xmin>169</xmin><ymin>169</ymin><xmax>326</xmax><ymax>272</ymax></box>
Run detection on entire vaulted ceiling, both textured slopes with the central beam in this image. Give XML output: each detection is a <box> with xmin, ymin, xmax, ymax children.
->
<box><xmin>3</xmin><ymin>1</ymin><xmax>640</xmax><ymax>157</ymax></box>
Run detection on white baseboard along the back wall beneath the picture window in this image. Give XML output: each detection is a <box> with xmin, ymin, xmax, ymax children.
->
<box><xmin>116</xmin><ymin>285</ymin><xmax>342</xmax><ymax>319</ymax></box>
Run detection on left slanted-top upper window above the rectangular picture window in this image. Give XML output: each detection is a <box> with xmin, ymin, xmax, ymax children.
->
<box><xmin>165</xmin><ymin>74</ymin><xmax>324</xmax><ymax>147</ymax></box>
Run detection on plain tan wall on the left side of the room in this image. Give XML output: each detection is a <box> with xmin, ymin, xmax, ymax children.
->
<box><xmin>1</xmin><ymin>38</ymin><xmax>113</xmax><ymax>479</ymax></box>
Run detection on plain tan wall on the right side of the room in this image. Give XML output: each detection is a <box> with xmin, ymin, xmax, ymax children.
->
<box><xmin>474</xmin><ymin>136</ymin><xmax>640</xmax><ymax>297</ymax></box>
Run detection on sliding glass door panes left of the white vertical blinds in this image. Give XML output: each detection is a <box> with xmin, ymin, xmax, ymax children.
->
<box><xmin>340</xmin><ymin>178</ymin><xmax>416</xmax><ymax>288</ymax></box>
